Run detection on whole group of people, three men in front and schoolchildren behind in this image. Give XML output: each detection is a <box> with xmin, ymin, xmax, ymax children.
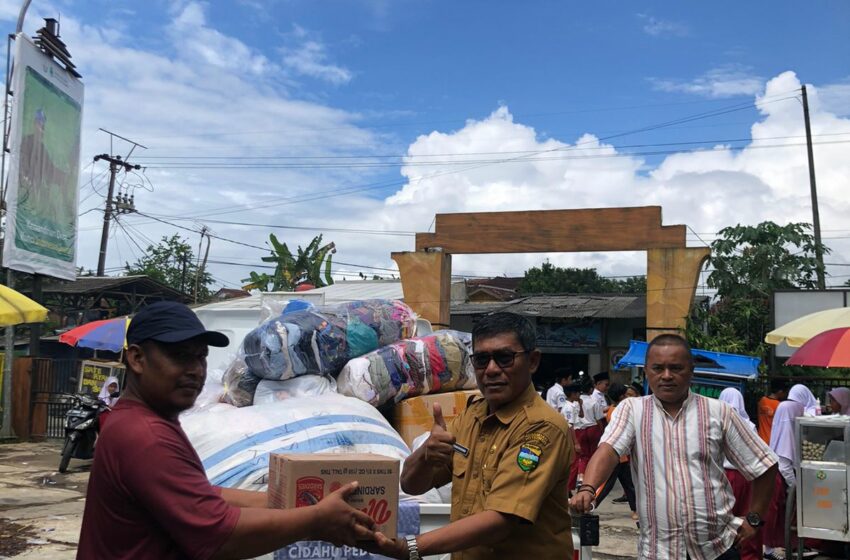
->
<box><xmin>77</xmin><ymin>302</ymin><xmax>850</xmax><ymax>560</ymax></box>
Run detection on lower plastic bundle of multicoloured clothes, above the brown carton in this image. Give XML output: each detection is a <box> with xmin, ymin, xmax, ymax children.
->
<box><xmin>337</xmin><ymin>331</ymin><xmax>476</xmax><ymax>406</ymax></box>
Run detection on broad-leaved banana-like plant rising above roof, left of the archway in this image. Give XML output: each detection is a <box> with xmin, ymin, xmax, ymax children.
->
<box><xmin>242</xmin><ymin>233</ymin><xmax>336</xmax><ymax>292</ymax></box>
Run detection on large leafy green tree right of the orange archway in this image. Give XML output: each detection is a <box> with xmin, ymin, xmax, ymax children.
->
<box><xmin>687</xmin><ymin>222</ymin><xmax>829</xmax><ymax>360</ymax></box>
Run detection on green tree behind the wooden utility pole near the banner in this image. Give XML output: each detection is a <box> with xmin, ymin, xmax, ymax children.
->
<box><xmin>124</xmin><ymin>234</ymin><xmax>214</xmax><ymax>301</ymax></box>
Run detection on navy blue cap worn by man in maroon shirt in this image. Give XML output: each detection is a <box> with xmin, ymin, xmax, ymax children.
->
<box><xmin>127</xmin><ymin>301</ymin><xmax>230</xmax><ymax>347</ymax></box>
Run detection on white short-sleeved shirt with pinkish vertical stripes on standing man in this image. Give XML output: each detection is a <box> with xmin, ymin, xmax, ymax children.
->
<box><xmin>602</xmin><ymin>393</ymin><xmax>776</xmax><ymax>560</ymax></box>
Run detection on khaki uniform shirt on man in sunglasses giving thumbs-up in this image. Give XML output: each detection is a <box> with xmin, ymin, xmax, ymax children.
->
<box><xmin>448</xmin><ymin>385</ymin><xmax>574</xmax><ymax>560</ymax></box>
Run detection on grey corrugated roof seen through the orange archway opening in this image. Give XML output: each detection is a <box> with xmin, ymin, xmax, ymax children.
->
<box><xmin>452</xmin><ymin>294</ymin><xmax>646</xmax><ymax>319</ymax></box>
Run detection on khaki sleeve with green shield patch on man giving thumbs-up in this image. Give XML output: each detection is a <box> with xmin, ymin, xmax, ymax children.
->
<box><xmin>483</xmin><ymin>422</ymin><xmax>573</xmax><ymax>523</ymax></box>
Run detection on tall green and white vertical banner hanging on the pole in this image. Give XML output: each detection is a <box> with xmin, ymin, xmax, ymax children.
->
<box><xmin>3</xmin><ymin>33</ymin><xmax>83</xmax><ymax>280</ymax></box>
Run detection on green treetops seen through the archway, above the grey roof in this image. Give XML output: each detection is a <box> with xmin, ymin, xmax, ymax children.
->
<box><xmin>518</xmin><ymin>261</ymin><xmax>646</xmax><ymax>295</ymax></box>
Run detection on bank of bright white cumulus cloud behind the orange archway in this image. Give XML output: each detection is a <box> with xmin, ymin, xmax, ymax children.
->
<box><xmin>379</xmin><ymin>72</ymin><xmax>850</xmax><ymax>283</ymax></box>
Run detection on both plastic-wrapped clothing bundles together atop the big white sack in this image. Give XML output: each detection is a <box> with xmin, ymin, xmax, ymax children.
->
<box><xmin>219</xmin><ymin>300</ymin><xmax>475</xmax><ymax>407</ymax></box>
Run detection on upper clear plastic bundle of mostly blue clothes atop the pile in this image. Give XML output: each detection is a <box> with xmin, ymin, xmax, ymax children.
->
<box><xmin>242</xmin><ymin>300</ymin><xmax>416</xmax><ymax>380</ymax></box>
